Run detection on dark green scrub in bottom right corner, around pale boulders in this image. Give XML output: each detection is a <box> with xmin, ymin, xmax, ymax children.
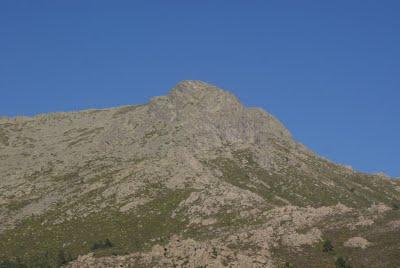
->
<box><xmin>273</xmin><ymin>210</ymin><xmax>400</xmax><ymax>268</ymax></box>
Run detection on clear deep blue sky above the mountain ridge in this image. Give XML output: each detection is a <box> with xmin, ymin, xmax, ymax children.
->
<box><xmin>0</xmin><ymin>0</ymin><xmax>400</xmax><ymax>176</ymax></box>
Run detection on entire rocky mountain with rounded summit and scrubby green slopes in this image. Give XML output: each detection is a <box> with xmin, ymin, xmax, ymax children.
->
<box><xmin>0</xmin><ymin>81</ymin><xmax>400</xmax><ymax>268</ymax></box>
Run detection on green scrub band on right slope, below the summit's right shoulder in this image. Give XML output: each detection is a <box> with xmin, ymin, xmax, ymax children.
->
<box><xmin>205</xmin><ymin>149</ymin><xmax>400</xmax><ymax>208</ymax></box>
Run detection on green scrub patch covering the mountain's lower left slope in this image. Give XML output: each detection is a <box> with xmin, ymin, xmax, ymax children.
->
<box><xmin>0</xmin><ymin>189</ymin><xmax>190</xmax><ymax>267</ymax></box>
